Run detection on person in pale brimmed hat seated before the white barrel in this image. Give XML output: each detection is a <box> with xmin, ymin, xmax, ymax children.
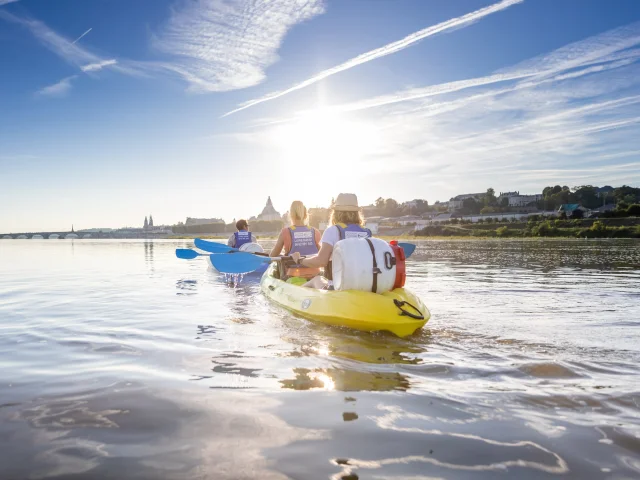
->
<box><xmin>291</xmin><ymin>193</ymin><xmax>371</xmax><ymax>288</ymax></box>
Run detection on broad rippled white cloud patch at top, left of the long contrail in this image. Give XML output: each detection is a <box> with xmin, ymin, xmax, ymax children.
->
<box><xmin>153</xmin><ymin>0</ymin><xmax>324</xmax><ymax>91</ymax></box>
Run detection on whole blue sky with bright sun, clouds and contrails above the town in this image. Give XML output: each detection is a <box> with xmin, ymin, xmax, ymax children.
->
<box><xmin>0</xmin><ymin>0</ymin><xmax>640</xmax><ymax>233</ymax></box>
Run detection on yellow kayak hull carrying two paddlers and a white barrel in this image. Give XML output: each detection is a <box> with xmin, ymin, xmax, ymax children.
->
<box><xmin>260</xmin><ymin>263</ymin><xmax>431</xmax><ymax>337</ymax></box>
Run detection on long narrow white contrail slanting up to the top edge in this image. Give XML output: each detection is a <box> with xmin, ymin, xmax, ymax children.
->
<box><xmin>224</xmin><ymin>0</ymin><xmax>524</xmax><ymax>116</ymax></box>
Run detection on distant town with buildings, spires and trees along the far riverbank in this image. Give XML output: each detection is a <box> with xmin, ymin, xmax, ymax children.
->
<box><xmin>5</xmin><ymin>185</ymin><xmax>640</xmax><ymax>239</ymax></box>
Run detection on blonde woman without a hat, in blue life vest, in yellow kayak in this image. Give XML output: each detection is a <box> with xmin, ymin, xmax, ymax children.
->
<box><xmin>269</xmin><ymin>200</ymin><xmax>320</xmax><ymax>282</ymax></box>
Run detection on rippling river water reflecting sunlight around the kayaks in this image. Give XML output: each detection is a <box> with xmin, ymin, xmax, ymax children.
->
<box><xmin>0</xmin><ymin>240</ymin><xmax>640</xmax><ymax>480</ymax></box>
